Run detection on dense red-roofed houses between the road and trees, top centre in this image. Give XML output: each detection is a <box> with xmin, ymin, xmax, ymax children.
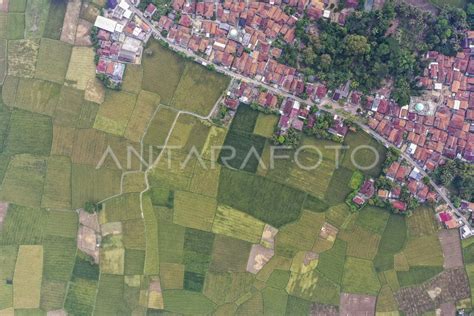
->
<box><xmin>152</xmin><ymin>0</ymin><xmax>358</xmax><ymax>95</ymax></box>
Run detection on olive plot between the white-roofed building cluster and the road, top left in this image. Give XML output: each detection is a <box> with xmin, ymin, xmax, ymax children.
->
<box><xmin>142</xmin><ymin>41</ymin><xmax>185</xmax><ymax>105</ymax></box>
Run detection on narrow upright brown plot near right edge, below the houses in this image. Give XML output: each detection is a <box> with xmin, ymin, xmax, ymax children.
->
<box><xmin>438</xmin><ymin>229</ymin><xmax>464</xmax><ymax>269</ymax></box>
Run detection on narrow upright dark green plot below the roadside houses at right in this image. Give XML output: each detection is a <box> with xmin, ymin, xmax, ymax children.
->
<box><xmin>374</xmin><ymin>214</ymin><xmax>407</xmax><ymax>271</ymax></box>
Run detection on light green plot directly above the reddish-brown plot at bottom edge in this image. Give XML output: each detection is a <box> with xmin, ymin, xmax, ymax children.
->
<box><xmin>342</xmin><ymin>257</ymin><xmax>380</xmax><ymax>295</ymax></box>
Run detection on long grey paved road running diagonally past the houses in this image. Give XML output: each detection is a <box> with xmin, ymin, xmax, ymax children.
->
<box><xmin>130</xmin><ymin>5</ymin><xmax>462</xmax><ymax>217</ymax></box>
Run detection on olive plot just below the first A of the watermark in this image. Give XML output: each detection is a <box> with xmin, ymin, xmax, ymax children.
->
<box><xmin>71</xmin><ymin>164</ymin><xmax>121</xmax><ymax>208</ymax></box>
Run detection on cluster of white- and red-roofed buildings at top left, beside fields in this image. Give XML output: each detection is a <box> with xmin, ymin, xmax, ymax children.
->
<box><xmin>94</xmin><ymin>0</ymin><xmax>152</xmax><ymax>84</ymax></box>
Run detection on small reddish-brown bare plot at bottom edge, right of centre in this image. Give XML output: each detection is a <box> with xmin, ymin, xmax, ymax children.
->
<box><xmin>339</xmin><ymin>293</ymin><xmax>377</xmax><ymax>316</ymax></box>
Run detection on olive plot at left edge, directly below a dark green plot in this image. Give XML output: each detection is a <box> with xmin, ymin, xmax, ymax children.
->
<box><xmin>0</xmin><ymin>154</ymin><xmax>46</xmax><ymax>207</ymax></box>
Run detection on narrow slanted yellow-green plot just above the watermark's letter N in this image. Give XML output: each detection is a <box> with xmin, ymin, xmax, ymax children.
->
<box><xmin>125</xmin><ymin>91</ymin><xmax>160</xmax><ymax>142</ymax></box>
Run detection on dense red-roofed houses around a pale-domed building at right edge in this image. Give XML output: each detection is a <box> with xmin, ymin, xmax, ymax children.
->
<box><xmin>367</xmin><ymin>32</ymin><xmax>474</xmax><ymax>175</ymax></box>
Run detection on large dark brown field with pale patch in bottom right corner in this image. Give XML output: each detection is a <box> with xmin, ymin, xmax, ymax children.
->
<box><xmin>395</xmin><ymin>268</ymin><xmax>471</xmax><ymax>316</ymax></box>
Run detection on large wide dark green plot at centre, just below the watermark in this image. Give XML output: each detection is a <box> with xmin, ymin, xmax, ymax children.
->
<box><xmin>218</xmin><ymin>168</ymin><xmax>306</xmax><ymax>227</ymax></box>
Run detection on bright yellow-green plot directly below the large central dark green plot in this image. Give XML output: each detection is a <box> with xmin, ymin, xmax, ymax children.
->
<box><xmin>212</xmin><ymin>205</ymin><xmax>265</xmax><ymax>243</ymax></box>
